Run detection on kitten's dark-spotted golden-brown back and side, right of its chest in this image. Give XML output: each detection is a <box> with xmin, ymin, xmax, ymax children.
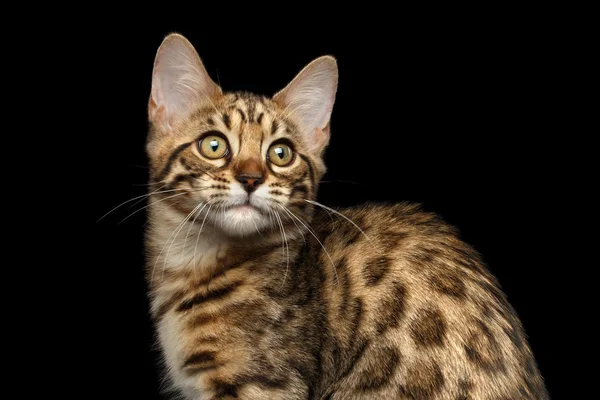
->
<box><xmin>312</xmin><ymin>203</ymin><xmax>547</xmax><ymax>399</ymax></box>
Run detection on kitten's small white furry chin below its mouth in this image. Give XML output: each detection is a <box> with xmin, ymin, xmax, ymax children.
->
<box><xmin>217</xmin><ymin>204</ymin><xmax>269</xmax><ymax>236</ymax></box>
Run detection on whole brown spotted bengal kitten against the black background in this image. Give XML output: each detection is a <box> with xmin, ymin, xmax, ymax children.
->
<box><xmin>146</xmin><ymin>35</ymin><xmax>548</xmax><ymax>400</ymax></box>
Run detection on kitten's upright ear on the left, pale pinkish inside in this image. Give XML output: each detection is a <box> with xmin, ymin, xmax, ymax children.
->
<box><xmin>148</xmin><ymin>34</ymin><xmax>222</xmax><ymax>132</ymax></box>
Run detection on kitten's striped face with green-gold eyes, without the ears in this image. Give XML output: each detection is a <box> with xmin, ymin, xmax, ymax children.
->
<box><xmin>151</xmin><ymin>94</ymin><xmax>323</xmax><ymax>235</ymax></box>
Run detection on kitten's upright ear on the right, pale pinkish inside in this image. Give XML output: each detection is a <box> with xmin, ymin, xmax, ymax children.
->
<box><xmin>273</xmin><ymin>56</ymin><xmax>338</xmax><ymax>156</ymax></box>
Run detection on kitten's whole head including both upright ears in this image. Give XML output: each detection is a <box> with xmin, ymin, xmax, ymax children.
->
<box><xmin>147</xmin><ymin>34</ymin><xmax>338</xmax><ymax>236</ymax></box>
